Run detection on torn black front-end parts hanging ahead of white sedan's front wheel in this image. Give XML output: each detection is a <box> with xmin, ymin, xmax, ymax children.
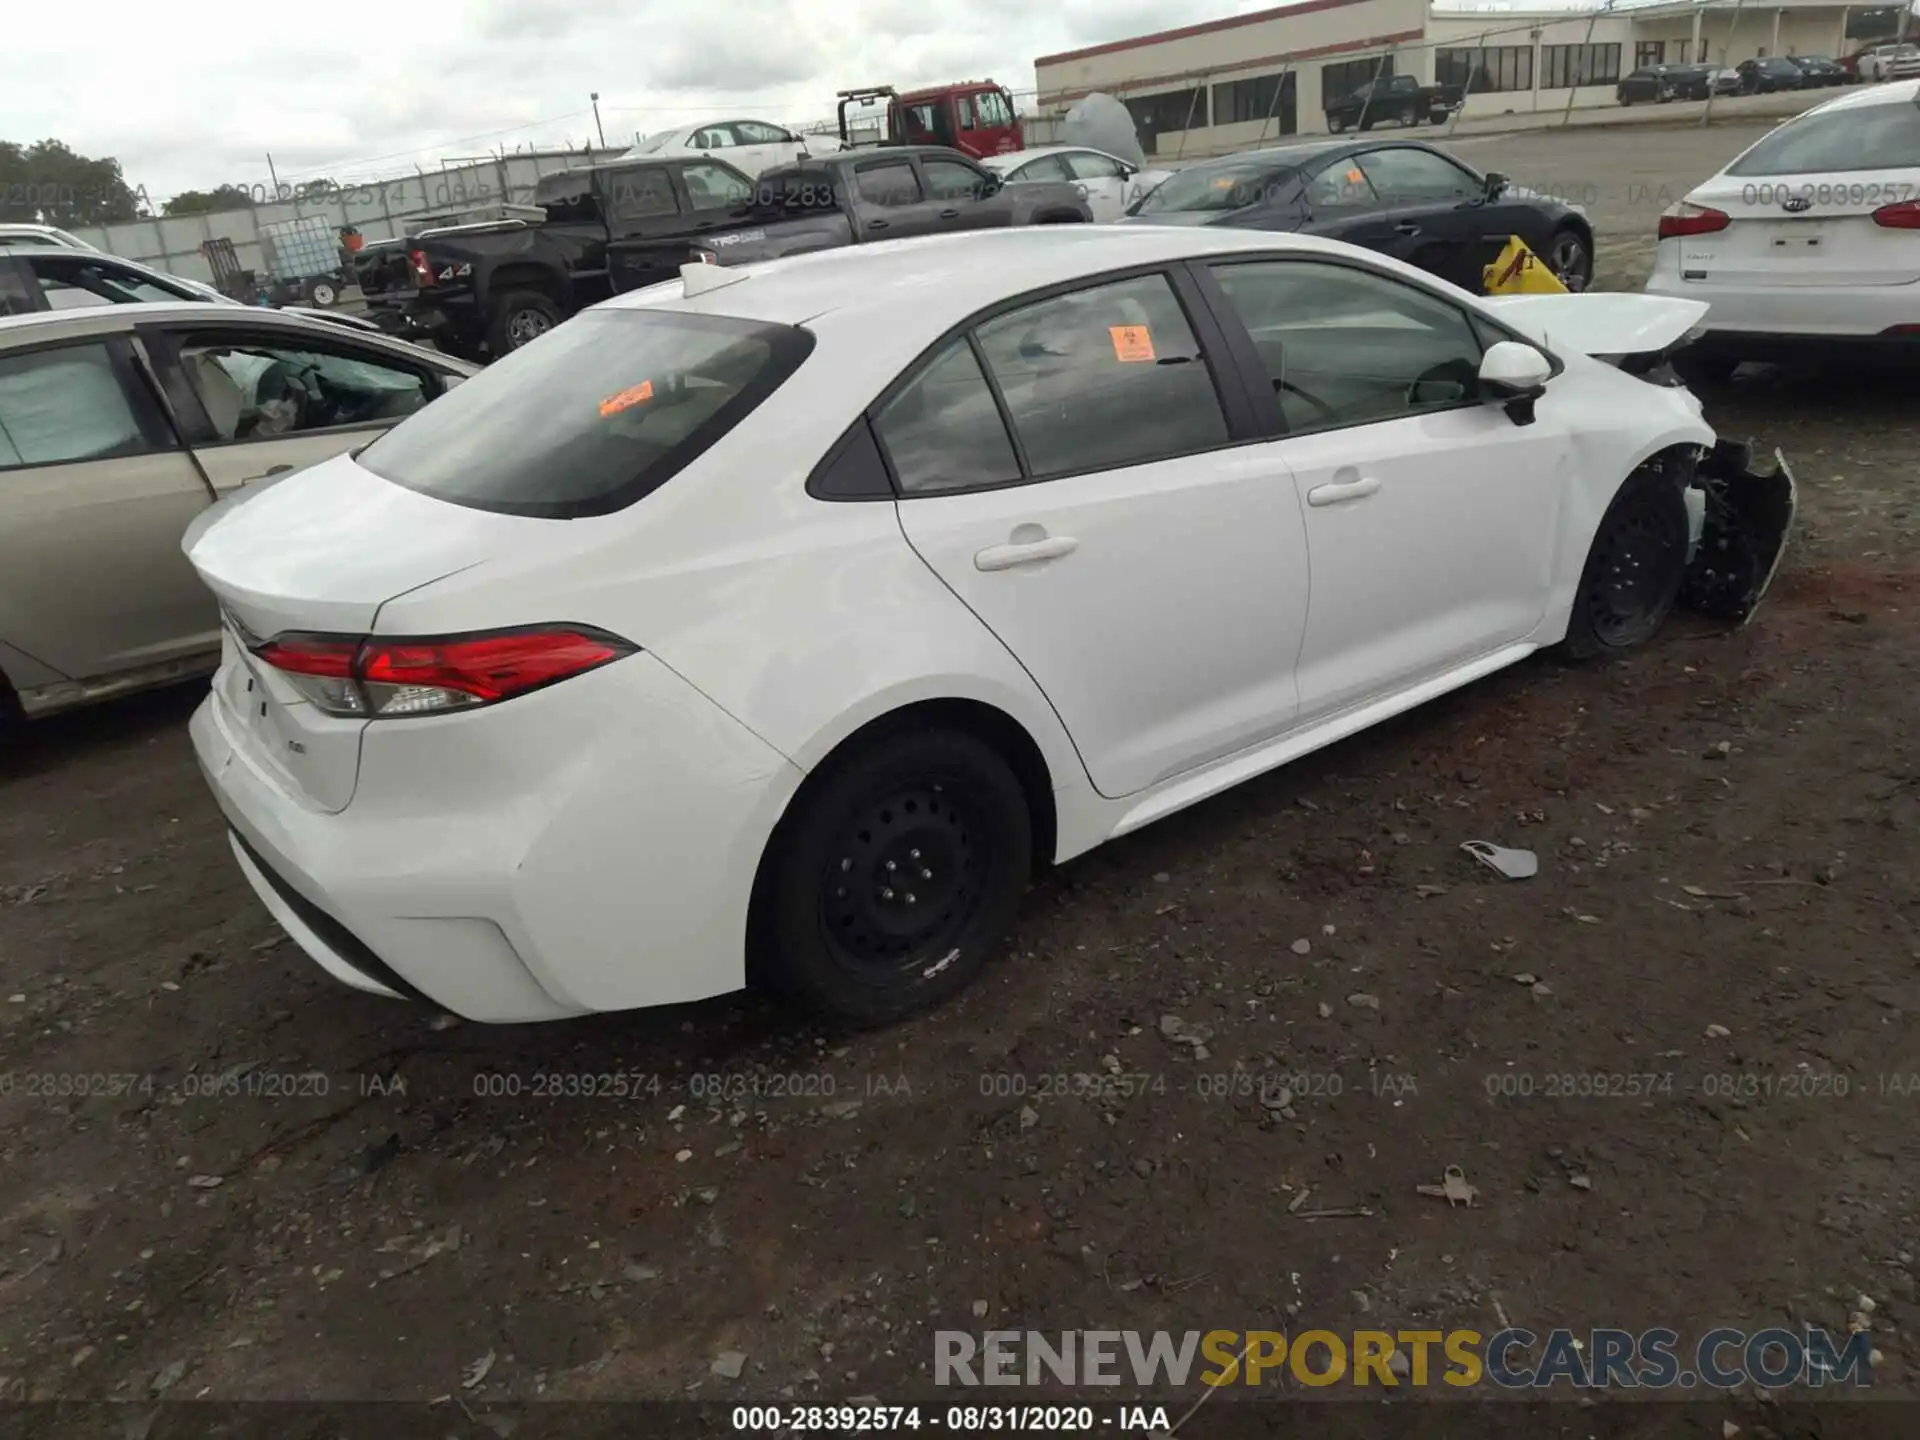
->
<box><xmin>1680</xmin><ymin>440</ymin><xmax>1799</xmax><ymax>624</ymax></box>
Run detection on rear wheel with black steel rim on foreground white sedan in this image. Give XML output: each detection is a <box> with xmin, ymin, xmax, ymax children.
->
<box><xmin>749</xmin><ymin>730</ymin><xmax>1033</xmax><ymax>1025</ymax></box>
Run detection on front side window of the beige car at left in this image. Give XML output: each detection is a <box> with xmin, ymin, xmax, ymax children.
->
<box><xmin>180</xmin><ymin>330</ymin><xmax>430</xmax><ymax>444</ymax></box>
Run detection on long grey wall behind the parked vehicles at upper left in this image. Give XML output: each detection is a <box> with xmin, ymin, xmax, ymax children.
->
<box><xmin>71</xmin><ymin>150</ymin><xmax>620</xmax><ymax>282</ymax></box>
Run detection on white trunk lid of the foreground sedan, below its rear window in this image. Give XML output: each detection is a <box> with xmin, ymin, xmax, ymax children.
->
<box><xmin>182</xmin><ymin>455</ymin><xmax>530</xmax><ymax>812</ymax></box>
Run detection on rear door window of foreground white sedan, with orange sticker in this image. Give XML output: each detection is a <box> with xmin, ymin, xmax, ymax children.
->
<box><xmin>977</xmin><ymin>275</ymin><xmax>1227</xmax><ymax>480</ymax></box>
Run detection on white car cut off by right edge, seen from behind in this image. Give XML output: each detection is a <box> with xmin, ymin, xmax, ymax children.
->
<box><xmin>1645</xmin><ymin>81</ymin><xmax>1920</xmax><ymax>378</ymax></box>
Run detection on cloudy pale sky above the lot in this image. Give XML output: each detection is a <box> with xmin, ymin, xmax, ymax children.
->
<box><xmin>0</xmin><ymin>0</ymin><xmax>1228</xmax><ymax>204</ymax></box>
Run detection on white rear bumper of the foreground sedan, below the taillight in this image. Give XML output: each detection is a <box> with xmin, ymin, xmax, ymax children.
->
<box><xmin>192</xmin><ymin>655</ymin><xmax>801</xmax><ymax>1023</ymax></box>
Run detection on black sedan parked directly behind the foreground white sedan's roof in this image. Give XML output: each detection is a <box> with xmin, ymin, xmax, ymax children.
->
<box><xmin>1121</xmin><ymin>138</ymin><xmax>1594</xmax><ymax>294</ymax></box>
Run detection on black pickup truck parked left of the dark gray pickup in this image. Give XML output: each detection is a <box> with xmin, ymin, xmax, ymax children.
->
<box><xmin>357</xmin><ymin>159</ymin><xmax>755</xmax><ymax>359</ymax></box>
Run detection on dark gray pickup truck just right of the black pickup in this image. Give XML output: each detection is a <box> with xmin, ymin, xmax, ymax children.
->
<box><xmin>607</xmin><ymin>146</ymin><xmax>1092</xmax><ymax>290</ymax></box>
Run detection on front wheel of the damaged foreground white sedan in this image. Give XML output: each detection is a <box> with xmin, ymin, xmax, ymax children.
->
<box><xmin>1559</xmin><ymin>465</ymin><xmax>1688</xmax><ymax>660</ymax></box>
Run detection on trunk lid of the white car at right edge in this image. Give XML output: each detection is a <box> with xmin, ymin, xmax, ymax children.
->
<box><xmin>1678</xmin><ymin>169</ymin><xmax>1920</xmax><ymax>288</ymax></box>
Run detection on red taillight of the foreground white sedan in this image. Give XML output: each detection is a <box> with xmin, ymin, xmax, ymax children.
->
<box><xmin>253</xmin><ymin>626</ymin><xmax>637</xmax><ymax>720</ymax></box>
